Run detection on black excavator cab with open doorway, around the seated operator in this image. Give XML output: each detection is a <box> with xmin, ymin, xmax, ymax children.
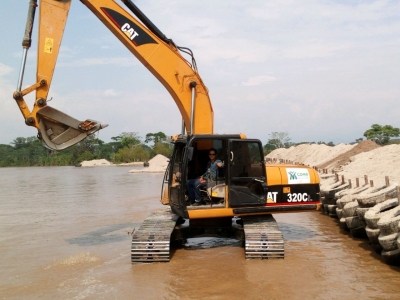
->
<box><xmin>168</xmin><ymin>135</ymin><xmax>267</xmax><ymax>218</ymax></box>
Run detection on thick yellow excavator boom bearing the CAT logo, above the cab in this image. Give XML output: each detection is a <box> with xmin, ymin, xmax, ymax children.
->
<box><xmin>81</xmin><ymin>0</ymin><xmax>214</xmax><ymax>134</ymax></box>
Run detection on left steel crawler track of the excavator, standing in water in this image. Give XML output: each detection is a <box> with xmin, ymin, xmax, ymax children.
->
<box><xmin>131</xmin><ymin>209</ymin><xmax>176</xmax><ymax>263</ymax></box>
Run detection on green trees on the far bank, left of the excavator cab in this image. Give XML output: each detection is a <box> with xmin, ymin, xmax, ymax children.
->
<box><xmin>0</xmin><ymin>132</ymin><xmax>172</xmax><ymax>167</ymax></box>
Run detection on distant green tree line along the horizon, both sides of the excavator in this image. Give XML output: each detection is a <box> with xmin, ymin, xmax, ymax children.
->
<box><xmin>0</xmin><ymin>124</ymin><xmax>400</xmax><ymax>167</ymax></box>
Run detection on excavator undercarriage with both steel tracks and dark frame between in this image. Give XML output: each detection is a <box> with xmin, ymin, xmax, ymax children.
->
<box><xmin>131</xmin><ymin>209</ymin><xmax>284</xmax><ymax>263</ymax></box>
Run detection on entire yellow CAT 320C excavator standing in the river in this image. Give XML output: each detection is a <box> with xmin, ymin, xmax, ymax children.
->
<box><xmin>13</xmin><ymin>0</ymin><xmax>320</xmax><ymax>262</ymax></box>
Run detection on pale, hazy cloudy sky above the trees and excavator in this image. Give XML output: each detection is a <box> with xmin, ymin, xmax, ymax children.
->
<box><xmin>0</xmin><ymin>0</ymin><xmax>400</xmax><ymax>144</ymax></box>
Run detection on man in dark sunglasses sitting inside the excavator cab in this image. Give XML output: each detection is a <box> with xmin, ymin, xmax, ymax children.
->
<box><xmin>186</xmin><ymin>148</ymin><xmax>224</xmax><ymax>206</ymax></box>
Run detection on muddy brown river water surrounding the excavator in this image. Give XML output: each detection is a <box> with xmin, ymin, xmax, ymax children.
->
<box><xmin>0</xmin><ymin>166</ymin><xmax>400</xmax><ymax>300</ymax></box>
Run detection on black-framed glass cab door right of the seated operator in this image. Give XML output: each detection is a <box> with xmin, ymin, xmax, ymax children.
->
<box><xmin>225</xmin><ymin>139</ymin><xmax>267</xmax><ymax>207</ymax></box>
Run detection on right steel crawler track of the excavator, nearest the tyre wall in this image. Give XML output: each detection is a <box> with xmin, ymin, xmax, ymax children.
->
<box><xmin>242</xmin><ymin>215</ymin><xmax>285</xmax><ymax>259</ymax></box>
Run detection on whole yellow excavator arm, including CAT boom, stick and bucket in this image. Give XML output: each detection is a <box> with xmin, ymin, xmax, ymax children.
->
<box><xmin>13</xmin><ymin>0</ymin><xmax>214</xmax><ymax>150</ymax></box>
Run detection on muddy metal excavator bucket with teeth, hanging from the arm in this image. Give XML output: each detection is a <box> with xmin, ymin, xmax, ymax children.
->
<box><xmin>36</xmin><ymin>106</ymin><xmax>108</xmax><ymax>150</ymax></box>
